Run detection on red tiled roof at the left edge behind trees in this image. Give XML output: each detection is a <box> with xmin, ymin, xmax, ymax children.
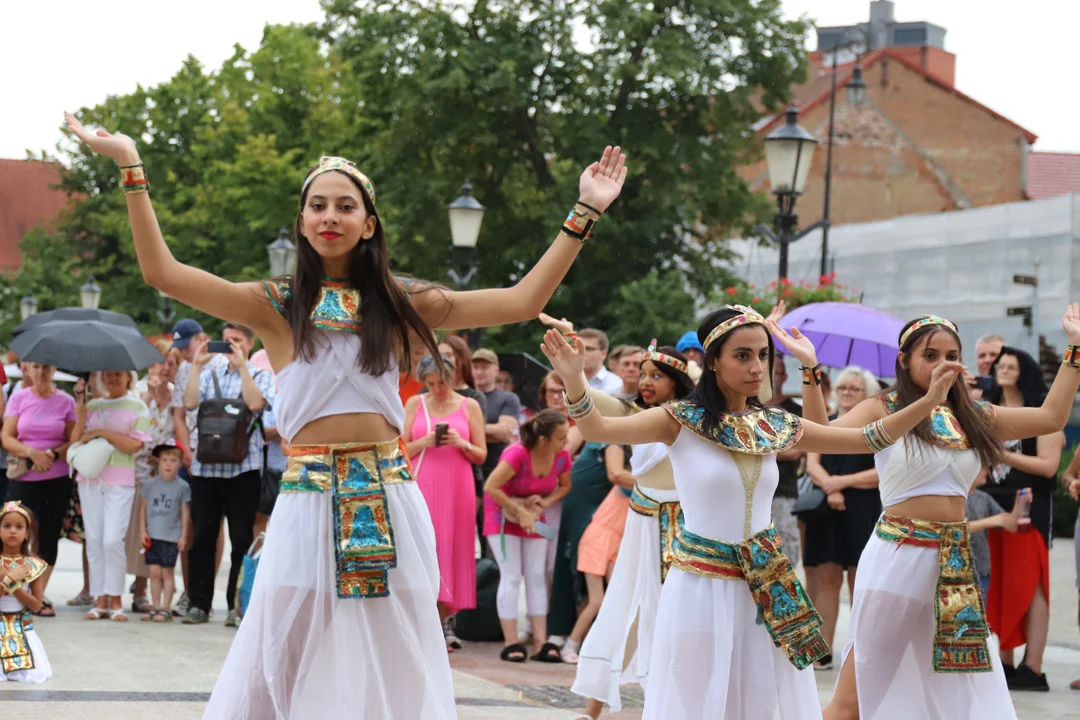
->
<box><xmin>0</xmin><ymin>160</ymin><xmax>68</xmax><ymax>272</ymax></box>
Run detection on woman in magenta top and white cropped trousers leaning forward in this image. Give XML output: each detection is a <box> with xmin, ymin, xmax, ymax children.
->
<box><xmin>484</xmin><ymin>409</ymin><xmax>573</xmax><ymax>663</ymax></box>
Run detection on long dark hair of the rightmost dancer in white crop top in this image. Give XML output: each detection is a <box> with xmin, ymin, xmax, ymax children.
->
<box><xmin>886</xmin><ymin>317</ymin><xmax>1002</xmax><ymax>467</ymax></box>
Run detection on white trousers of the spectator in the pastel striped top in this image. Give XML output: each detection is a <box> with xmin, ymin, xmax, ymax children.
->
<box><xmin>79</xmin><ymin>480</ymin><xmax>135</xmax><ymax>597</ymax></box>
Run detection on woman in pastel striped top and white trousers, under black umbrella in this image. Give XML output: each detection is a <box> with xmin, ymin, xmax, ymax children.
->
<box><xmin>76</xmin><ymin>370</ymin><xmax>150</xmax><ymax>622</ymax></box>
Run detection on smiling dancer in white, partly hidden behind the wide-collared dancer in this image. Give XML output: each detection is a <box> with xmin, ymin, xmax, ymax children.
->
<box><xmin>541</xmin><ymin>328</ymin><xmax>693</xmax><ymax>720</ymax></box>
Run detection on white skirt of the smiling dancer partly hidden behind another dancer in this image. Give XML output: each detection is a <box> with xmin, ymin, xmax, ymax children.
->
<box><xmin>570</xmin><ymin>488</ymin><xmax>678</xmax><ymax>712</ymax></box>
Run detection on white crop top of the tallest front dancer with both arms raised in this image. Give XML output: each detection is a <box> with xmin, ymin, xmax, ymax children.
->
<box><xmin>274</xmin><ymin>330</ymin><xmax>405</xmax><ymax>440</ymax></box>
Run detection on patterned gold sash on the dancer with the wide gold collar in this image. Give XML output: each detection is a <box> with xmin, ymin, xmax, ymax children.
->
<box><xmin>672</xmin><ymin>526</ymin><xmax>829</xmax><ymax>670</ymax></box>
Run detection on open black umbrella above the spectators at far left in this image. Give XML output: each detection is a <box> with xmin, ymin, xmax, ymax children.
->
<box><xmin>11</xmin><ymin>320</ymin><xmax>165</xmax><ymax>372</ymax></box>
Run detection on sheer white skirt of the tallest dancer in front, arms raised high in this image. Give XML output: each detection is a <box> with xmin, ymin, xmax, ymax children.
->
<box><xmin>203</xmin><ymin>483</ymin><xmax>457</xmax><ymax>720</ymax></box>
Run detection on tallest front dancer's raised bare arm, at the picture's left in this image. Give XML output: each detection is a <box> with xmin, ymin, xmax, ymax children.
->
<box><xmin>67</xmin><ymin>114</ymin><xmax>283</xmax><ymax>339</ymax></box>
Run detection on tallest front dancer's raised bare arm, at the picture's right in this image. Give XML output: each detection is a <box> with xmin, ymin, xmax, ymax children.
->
<box><xmin>413</xmin><ymin>146</ymin><xmax>626</xmax><ymax>329</ymax></box>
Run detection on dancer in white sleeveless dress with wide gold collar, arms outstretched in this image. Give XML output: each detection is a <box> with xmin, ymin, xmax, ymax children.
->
<box><xmin>542</xmin><ymin>305</ymin><xmax>962</xmax><ymax>720</ymax></box>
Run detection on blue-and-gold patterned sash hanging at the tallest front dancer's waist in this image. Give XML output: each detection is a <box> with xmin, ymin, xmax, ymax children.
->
<box><xmin>281</xmin><ymin>438</ymin><xmax>415</xmax><ymax>598</ymax></box>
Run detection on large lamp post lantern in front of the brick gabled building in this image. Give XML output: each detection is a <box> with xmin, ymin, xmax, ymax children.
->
<box><xmin>757</xmin><ymin>105</ymin><xmax>828</xmax><ymax>285</ymax></box>
